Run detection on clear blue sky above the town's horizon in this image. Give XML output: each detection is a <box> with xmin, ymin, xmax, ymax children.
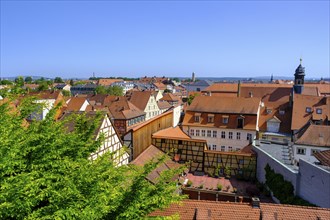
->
<box><xmin>0</xmin><ymin>0</ymin><xmax>330</xmax><ymax>78</ymax></box>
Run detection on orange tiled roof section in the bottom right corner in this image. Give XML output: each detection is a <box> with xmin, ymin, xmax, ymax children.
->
<box><xmin>260</xmin><ymin>203</ymin><xmax>330</xmax><ymax>220</ymax></box>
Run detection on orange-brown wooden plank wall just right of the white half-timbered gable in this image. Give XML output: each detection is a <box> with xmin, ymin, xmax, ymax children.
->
<box><xmin>124</xmin><ymin>110</ymin><xmax>173</xmax><ymax>160</ymax></box>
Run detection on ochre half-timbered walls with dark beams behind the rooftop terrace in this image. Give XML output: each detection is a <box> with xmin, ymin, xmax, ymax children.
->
<box><xmin>152</xmin><ymin>137</ymin><xmax>257</xmax><ymax>180</ymax></box>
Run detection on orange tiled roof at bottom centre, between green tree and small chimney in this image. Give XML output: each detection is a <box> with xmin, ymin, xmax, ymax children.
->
<box><xmin>149</xmin><ymin>200</ymin><xmax>260</xmax><ymax>220</ymax></box>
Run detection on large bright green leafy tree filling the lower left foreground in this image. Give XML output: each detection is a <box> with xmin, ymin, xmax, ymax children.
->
<box><xmin>0</xmin><ymin>99</ymin><xmax>181</xmax><ymax>219</ymax></box>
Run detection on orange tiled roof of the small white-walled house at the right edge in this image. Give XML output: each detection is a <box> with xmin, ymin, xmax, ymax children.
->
<box><xmin>296</xmin><ymin>124</ymin><xmax>330</xmax><ymax>147</ymax></box>
